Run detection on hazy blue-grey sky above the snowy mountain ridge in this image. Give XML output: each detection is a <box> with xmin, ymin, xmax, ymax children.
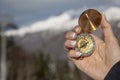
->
<box><xmin>0</xmin><ymin>0</ymin><xmax>120</xmax><ymax>25</ymax></box>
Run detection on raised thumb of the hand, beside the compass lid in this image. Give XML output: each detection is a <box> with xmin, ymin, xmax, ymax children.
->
<box><xmin>101</xmin><ymin>14</ymin><xmax>115</xmax><ymax>42</ymax></box>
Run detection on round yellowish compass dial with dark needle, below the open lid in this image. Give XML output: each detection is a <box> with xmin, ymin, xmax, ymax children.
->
<box><xmin>77</xmin><ymin>33</ymin><xmax>95</xmax><ymax>56</ymax></box>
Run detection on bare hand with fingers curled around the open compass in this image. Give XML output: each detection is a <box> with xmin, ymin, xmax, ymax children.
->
<box><xmin>64</xmin><ymin>15</ymin><xmax>120</xmax><ymax>80</ymax></box>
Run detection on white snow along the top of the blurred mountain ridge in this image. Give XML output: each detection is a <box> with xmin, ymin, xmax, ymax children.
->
<box><xmin>5</xmin><ymin>7</ymin><xmax>120</xmax><ymax>36</ymax></box>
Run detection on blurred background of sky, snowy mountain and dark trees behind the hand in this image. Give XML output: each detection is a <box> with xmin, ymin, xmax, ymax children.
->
<box><xmin>0</xmin><ymin>0</ymin><xmax>120</xmax><ymax>80</ymax></box>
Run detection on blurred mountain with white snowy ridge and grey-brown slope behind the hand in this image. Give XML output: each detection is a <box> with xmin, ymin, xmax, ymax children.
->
<box><xmin>6</xmin><ymin>7</ymin><xmax>120</xmax><ymax>58</ymax></box>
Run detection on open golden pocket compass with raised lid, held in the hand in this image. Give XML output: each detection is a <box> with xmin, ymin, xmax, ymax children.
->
<box><xmin>77</xmin><ymin>9</ymin><xmax>102</xmax><ymax>56</ymax></box>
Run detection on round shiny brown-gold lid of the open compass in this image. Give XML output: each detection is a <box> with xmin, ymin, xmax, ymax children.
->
<box><xmin>78</xmin><ymin>9</ymin><xmax>102</xmax><ymax>32</ymax></box>
